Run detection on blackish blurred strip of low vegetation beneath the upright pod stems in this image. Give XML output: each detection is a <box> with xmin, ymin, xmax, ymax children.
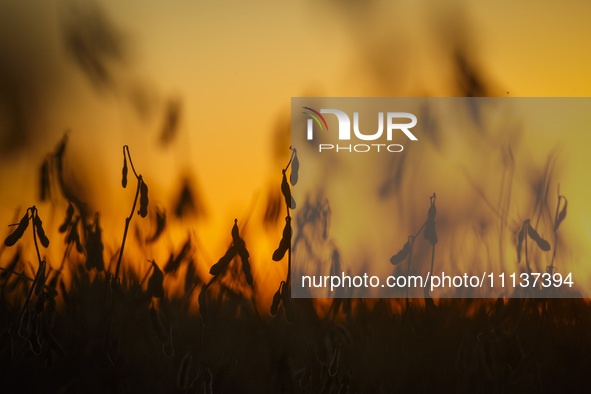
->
<box><xmin>0</xmin><ymin>274</ymin><xmax>591</xmax><ymax>393</ymax></box>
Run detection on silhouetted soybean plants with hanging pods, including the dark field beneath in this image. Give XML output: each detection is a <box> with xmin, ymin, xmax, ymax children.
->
<box><xmin>0</xmin><ymin>141</ymin><xmax>591</xmax><ymax>393</ymax></box>
